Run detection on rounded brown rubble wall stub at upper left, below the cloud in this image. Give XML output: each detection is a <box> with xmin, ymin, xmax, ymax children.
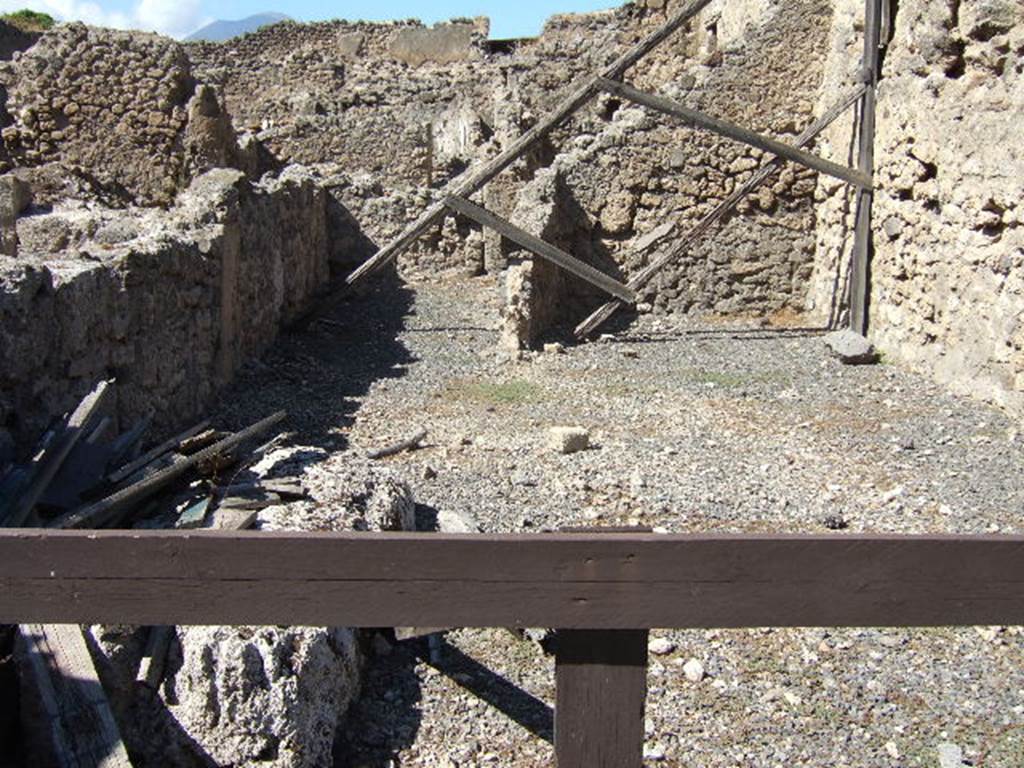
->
<box><xmin>0</xmin><ymin>24</ymin><xmax>245</xmax><ymax>206</ymax></box>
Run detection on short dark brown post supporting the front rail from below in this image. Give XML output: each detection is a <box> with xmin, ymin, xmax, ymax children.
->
<box><xmin>555</xmin><ymin>630</ymin><xmax>647</xmax><ymax>768</ymax></box>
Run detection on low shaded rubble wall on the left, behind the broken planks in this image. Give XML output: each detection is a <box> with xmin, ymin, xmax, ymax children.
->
<box><xmin>0</xmin><ymin>169</ymin><xmax>328</xmax><ymax>444</ymax></box>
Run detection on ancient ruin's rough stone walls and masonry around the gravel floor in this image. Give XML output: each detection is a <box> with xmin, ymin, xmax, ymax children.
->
<box><xmin>0</xmin><ymin>0</ymin><xmax>1024</xmax><ymax>766</ymax></box>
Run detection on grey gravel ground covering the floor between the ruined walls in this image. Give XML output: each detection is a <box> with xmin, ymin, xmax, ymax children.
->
<box><xmin>211</xmin><ymin>280</ymin><xmax>1024</xmax><ymax>768</ymax></box>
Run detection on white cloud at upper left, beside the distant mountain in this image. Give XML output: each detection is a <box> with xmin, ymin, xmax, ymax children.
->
<box><xmin>0</xmin><ymin>0</ymin><xmax>209</xmax><ymax>37</ymax></box>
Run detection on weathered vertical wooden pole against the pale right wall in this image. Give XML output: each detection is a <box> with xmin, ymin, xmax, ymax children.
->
<box><xmin>850</xmin><ymin>0</ymin><xmax>883</xmax><ymax>334</ymax></box>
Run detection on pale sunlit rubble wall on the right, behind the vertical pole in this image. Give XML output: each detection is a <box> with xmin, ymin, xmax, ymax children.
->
<box><xmin>812</xmin><ymin>0</ymin><xmax>1024</xmax><ymax>413</ymax></box>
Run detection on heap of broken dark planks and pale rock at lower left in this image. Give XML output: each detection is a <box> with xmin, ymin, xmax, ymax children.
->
<box><xmin>0</xmin><ymin>382</ymin><xmax>415</xmax><ymax>767</ymax></box>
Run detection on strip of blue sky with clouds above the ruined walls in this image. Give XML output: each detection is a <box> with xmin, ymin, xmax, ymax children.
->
<box><xmin>0</xmin><ymin>0</ymin><xmax>618</xmax><ymax>38</ymax></box>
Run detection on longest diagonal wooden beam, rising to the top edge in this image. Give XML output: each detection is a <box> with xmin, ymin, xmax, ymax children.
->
<box><xmin>346</xmin><ymin>0</ymin><xmax>711</xmax><ymax>285</ymax></box>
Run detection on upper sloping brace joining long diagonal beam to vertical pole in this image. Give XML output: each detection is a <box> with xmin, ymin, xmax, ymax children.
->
<box><xmin>601</xmin><ymin>79</ymin><xmax>871</xmax><ymax>189</ymax></box>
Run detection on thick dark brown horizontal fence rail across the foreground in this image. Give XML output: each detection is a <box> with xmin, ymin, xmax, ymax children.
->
<box><xmin>0</xmin><ymin>529</ymin><xmax>1024</xmax><ymax>629</ymax></box>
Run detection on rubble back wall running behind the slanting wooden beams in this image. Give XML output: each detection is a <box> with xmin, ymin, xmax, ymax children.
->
<box><xmin>187</xmin><ymin>0</ymin><xmax>830</xmax><ymax>319</ymax></box>
